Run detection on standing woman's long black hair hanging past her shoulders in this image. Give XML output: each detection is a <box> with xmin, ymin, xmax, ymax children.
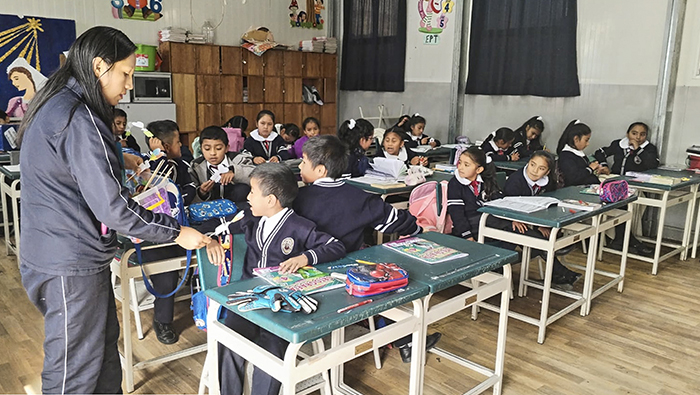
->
<box><xmin>17</xmin><ymin>26</ymin><xmax>136</xmax><ymax>142</ymax></box>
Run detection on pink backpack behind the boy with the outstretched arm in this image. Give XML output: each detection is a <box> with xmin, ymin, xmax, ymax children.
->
<box><xmin>408</xmin><ymin>181</ymin><xmax>452</xmax><ymax>233</ymax></box>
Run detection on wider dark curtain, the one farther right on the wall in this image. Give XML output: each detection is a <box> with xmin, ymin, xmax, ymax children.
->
<box><xmin>466</xmin><ymin>0</ymin><xmax>580</xmax><ymax>97</ymax></box>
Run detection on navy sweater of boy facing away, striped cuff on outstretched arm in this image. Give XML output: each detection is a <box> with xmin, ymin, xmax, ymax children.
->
<box><xmin>294</xmin><ymin>178</ymin><xmax>422</xmax><ymax>252</ymax></box>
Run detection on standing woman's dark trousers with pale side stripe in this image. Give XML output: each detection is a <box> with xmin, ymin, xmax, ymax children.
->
<box><xmin>20</xmin><ymin>265</ymin><xmax>122</xmax><ymax>394</ymax></box>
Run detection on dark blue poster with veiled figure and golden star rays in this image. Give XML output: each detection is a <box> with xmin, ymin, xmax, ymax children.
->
<box><xmin>0</xmin><ymin>14</ymin><xmax>75</xmax><ymax>118</ymax></box>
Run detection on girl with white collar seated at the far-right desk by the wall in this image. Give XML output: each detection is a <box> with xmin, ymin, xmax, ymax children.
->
<box><xmin>595</xmin><ymin>122</ymin><xmax>659</xmax><ymax>255</ymax></box>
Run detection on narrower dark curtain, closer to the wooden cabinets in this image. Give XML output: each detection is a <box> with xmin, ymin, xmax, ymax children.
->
<box><xmin>340</xmin><ymin>0</ymin><xmax>406</xmax><ymax>92</ymax></box>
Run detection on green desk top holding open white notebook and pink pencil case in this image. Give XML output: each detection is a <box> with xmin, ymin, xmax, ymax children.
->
<box><xmin>479</xmin><ymin>186</ymin><xmax>637</xmax><ymax>228</ymax></box>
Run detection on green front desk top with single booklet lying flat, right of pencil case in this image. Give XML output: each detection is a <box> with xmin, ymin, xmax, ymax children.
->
<box><xmin>326</xmin><ymin>232</ymin><xmax>518</xmax><ymax>293</ymax></box>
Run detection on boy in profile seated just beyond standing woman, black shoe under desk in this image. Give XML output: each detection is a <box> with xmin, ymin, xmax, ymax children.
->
<box><xmin>142</xmin><ymin>120</ymin><xmax>197</xmax><ymax>344</ymax></box>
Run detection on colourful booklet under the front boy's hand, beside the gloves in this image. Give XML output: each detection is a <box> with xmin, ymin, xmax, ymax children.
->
<box><xmin>253</xmin><ymin>266</ymin><xmax>345</xmax><ymax>295</ymax></box>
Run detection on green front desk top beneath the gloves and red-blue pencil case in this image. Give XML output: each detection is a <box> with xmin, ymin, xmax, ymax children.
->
<box><xmin>206</xmin><ymin>278</ymin><xmax>429</xmax><ymax>343</ymax></box>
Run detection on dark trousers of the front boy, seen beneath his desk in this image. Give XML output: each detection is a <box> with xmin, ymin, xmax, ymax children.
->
<box><xmin>219</xmin><ymin>312</ymin><xmax>289</xmax><ymax>395</ymax></box>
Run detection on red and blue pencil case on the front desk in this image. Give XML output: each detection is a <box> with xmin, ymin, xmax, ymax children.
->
<box><xmin>345</xmin><ymin>263</ymin><xmax>408</xmax><ymax>297</ymax></box>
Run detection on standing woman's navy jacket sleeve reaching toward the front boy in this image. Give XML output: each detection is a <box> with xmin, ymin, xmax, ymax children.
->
<box><xmin>64</xmin><ymin>107</ymin><xmax>180</xmax><ymax>242</ymax></box>
